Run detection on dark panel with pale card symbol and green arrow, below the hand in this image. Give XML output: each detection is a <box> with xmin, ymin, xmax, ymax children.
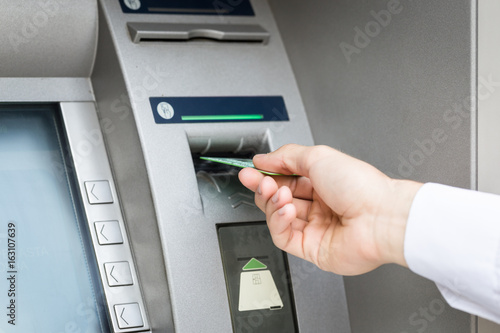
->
<box><xmin>218</xmin><ymin>223</ymin><xmax>297</xmax><ymax>333</ymax></box>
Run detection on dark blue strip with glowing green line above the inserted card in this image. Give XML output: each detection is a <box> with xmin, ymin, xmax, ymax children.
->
<box><xmin>149</xmin><ymin>96</ymin><xmax>289</xmax><ymax>124</ymax></box>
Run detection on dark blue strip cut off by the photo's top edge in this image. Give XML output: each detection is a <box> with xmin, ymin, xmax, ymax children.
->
<box><xmin>119</xmin><ymin>0</ymin><xmax>255</xmax><ymax>16</ymax></box>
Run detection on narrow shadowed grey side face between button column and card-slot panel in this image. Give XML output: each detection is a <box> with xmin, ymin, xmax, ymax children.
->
<box><xmin>91</xmin><ymin>11</ymin><xmax>174</xmax><ymax>333</ymax></box>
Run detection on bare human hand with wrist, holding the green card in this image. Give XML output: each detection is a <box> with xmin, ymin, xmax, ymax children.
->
<box><xmin>239</xmin><ymin>144</ymin><xmax>422</xmax><ymax>275</ymax></box>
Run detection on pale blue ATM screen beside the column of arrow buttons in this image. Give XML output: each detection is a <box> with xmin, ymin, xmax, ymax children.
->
<box><xmin>0</xmin><ymin>105</ymin><xmax>109</xmax><ymax>333</ymax></box>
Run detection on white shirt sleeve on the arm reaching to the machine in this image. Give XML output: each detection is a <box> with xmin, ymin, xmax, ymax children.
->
<box><xmin>404</xmin><ymin>183</ymin><xmax>500</xmax><ymax>323</ymax></box>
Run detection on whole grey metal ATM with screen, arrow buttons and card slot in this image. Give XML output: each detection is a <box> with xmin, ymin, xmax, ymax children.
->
<box><xmin>0</xmin><ymin>0</ymin><xmax>497</xmax><ymax>333</ymax></box>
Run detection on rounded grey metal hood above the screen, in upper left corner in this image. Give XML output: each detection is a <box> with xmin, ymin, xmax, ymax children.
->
<box><xmin>0</xmin><ymin>0</ymin><xmax>97</xmax><ymax>77</ymax></box>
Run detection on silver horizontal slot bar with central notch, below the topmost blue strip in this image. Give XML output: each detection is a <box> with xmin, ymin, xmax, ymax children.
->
<box><xmin>127</xmin><ymin>22</ymin><xmax>270</xmax><ymax>44</ymax></box>
